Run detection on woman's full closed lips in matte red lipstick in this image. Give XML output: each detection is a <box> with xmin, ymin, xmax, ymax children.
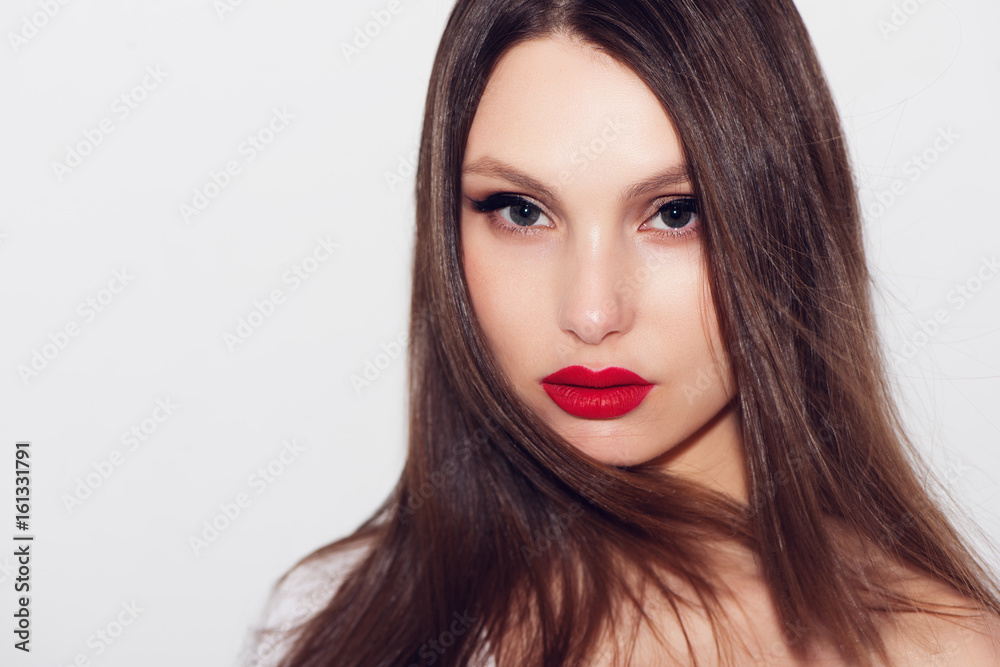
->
<box><xmin>542</xmin><ymin>366</ymin><xmax>653</xmax><ymax>419</ymax></box>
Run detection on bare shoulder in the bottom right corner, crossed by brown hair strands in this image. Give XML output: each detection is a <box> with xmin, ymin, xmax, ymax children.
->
<box><xmin>883</xmin><ymin>575</ymin><xmax>1000</xmax><ymax>667</ymax></box>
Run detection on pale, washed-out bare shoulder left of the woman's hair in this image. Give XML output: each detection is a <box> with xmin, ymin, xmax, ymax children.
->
<box><xmin>239</xmin><ymin>540</ymin><xmax>372</xmax><ymax>667</ymax></box>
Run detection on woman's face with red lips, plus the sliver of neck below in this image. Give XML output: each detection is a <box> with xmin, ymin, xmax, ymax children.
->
<box><xmin>461</xmin><ymin>36</ymin><xmax>745</xmax><ymax>498</ymax></box>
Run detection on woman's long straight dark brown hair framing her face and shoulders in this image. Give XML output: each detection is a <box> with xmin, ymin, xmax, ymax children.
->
<box><xmin>260</xmin><ymin>0</ymin><xmax>1000</xmax><ymax>667</ymax></box>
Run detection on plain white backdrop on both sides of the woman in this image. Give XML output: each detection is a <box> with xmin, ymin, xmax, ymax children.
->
<box><xmin>0</xmin><ymin>0</ymin><xmax>1000</xmax><ymax>666</ymax></box>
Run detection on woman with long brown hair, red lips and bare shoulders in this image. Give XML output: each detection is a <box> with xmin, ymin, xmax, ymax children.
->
<box><xmin>240</xmin><ymin>0</ymin><xmax>1000</xmax><ymax>667</ymax></box>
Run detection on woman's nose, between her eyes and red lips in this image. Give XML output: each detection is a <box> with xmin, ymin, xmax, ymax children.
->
<box><xmin>558</xmin><ymin>234</ymin><xmax>635</xmax><ymax>345</ymax></box>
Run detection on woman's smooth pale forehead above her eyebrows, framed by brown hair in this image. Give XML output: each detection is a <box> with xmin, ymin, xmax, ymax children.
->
<box><xmin>465</xmin><ymin>35</ymin><xmax>683</xmax><ymax>189</ymax></box>
